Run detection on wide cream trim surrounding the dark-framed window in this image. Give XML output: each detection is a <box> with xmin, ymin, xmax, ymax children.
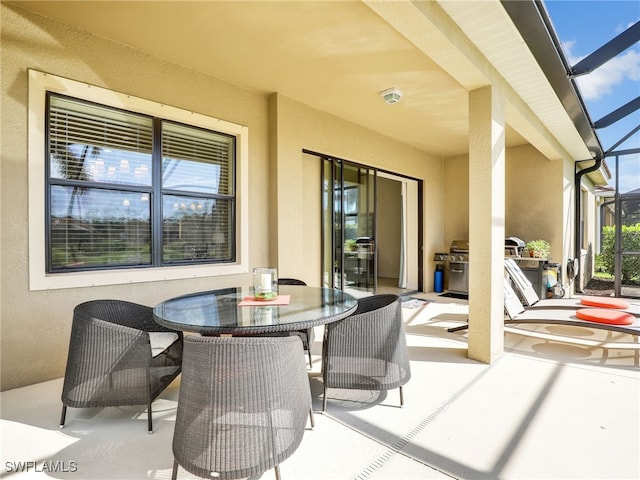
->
<box><xmin>28</xmin><ymin>69</ymin><xmax>249</xmax><ymax>291</ymax></box>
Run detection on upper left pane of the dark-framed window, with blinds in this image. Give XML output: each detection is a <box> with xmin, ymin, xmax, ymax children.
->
<box><xmin>49</xmin><ymin>96</ymin><xmax>153</xmax><ymax>186</ymax></box>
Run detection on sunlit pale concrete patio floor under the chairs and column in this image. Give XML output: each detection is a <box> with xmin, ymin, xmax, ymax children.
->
<box><xmin>0</xmin><ymin>294</ymin><xmax>640</xmax><ymax>480</ymax></box>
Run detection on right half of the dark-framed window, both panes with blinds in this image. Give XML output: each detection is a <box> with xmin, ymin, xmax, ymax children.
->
<box><xmin>162</xmin><ymin>122</ymin><xmax>235</xmax><ymax>264</ymax></box>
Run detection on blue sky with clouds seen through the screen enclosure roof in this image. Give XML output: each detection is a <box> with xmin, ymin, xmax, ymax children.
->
<box><xmin>544</xmin><ymin>0</ymin><xmax>640</xmax><ymax>193</ymax></box>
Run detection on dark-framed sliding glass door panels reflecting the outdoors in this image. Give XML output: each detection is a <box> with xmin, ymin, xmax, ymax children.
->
<box><xmin>322</xmin><ymin>158</ymin><xmax>376</xmax><ymax>292</ymax></box>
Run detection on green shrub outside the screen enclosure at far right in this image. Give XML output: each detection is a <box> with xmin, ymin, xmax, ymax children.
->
<box><xmin>596</xmin><ymin>223</ymin><xmax>640</xmax><ymax>285</ymax></box>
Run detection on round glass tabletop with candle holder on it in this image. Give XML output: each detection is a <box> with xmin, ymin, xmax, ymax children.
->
<box><xmin>153</xmin><ymin>285</ymin><xmax>358</xmax><ymax>335</ymax></box>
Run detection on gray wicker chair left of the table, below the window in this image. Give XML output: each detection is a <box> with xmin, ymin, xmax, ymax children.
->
<box><xmin>60</xmin><ymin>300</ymin><xmax>183</xmax><ymax>433</ymax></box>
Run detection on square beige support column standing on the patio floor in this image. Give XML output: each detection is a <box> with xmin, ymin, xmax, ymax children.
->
<box><xmin>469</xmin><ymin>86</ymin><xmax>505</xmax><ymax>363</ymax></box>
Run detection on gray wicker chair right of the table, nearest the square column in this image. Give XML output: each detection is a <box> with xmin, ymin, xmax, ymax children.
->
<box><xmin>322</xmin><ymin>295</ymin><xmax>411</xmax><ymax>411</ymax></box>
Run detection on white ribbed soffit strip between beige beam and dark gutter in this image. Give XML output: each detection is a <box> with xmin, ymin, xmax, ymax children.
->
<box><xmin>440</xmin><ymin>0</ymin><xmax>591</xmax><ymax>160</ymax></box>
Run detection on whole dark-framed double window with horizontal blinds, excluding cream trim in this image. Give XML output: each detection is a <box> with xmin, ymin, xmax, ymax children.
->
<box><xmin>46</xmin><ymin>94</ymin><xmax>235</xmax><ymax>273</ymax></box>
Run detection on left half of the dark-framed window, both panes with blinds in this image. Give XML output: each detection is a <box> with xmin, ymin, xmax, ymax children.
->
<box><xmin>48</xmin><ymin>96</ymin><xmax>153</xmax><ymax>272</ymax></box>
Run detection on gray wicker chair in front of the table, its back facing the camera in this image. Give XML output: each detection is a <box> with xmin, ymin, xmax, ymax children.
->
<box><xmin>172</xmin><ymin>335</ymin><xmax>311</xmax><ymax>480</ymax></box>
